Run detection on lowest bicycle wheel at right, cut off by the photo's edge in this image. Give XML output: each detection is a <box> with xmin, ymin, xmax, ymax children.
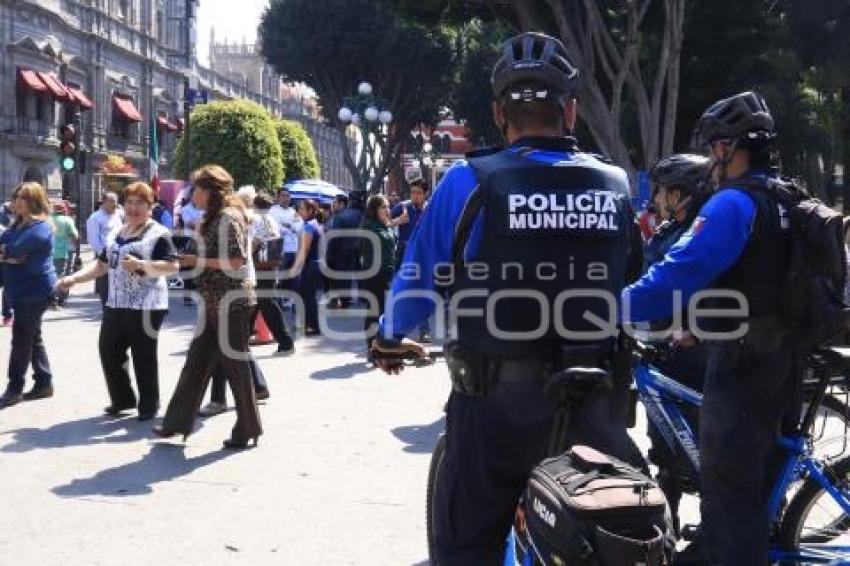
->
<box><xmin>778</xmin><ymin>458</ymin><xmax>850</xmax><ymax>558</ymax></box>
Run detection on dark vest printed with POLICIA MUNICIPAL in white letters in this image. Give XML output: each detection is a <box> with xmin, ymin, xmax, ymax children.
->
<box><xmin>452</xmin><ymin>140</ymin><xmax>633</xmax><ymax>358</ymax></box>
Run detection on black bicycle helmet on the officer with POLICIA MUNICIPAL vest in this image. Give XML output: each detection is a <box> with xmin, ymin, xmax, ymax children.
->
<box><xmin>490</xmin><ymin>32</ymin><xmax>579</xmax><ymax>98</ymax></box>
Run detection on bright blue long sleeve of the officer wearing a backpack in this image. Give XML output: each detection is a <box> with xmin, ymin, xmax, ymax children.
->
<box><xmin>621</xmin><ymin>188</ymin><xmax>756</xmax><ymax>322</ymax></box>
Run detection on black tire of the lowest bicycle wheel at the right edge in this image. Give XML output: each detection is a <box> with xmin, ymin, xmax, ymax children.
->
<box><xmin>777</xmin><ymin>457</ymin><xmax>850</xmax><ymax>550</ymax></box>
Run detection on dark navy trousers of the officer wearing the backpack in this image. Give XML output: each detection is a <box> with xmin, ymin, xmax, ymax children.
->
<box><xmin>700</xmin><ymin>338</ymin><xmax>799</xmax><ymax>566</ymax></box>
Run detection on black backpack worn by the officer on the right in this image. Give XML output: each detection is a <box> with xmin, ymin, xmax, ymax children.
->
<box><xmin>744</xmin><ymin>177</ymin><xmax>850</xmax><ymax>352</ymax></box>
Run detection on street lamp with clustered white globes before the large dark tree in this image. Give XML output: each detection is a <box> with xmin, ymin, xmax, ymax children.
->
<box><xmin>337</xmin><ymin>81</ymin><xmax>393</xmax><ymax>190</ymax></box>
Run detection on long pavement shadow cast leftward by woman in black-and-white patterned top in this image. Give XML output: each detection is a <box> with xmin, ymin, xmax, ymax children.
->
<box><xmin>0</xmin><ymin>409</ymin><xmax>200</xmax><ymax>452</ymax></box>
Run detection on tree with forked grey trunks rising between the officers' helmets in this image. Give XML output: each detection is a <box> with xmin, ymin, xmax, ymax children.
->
<box><xmin>384</xmin><ymin>0</ymin><xmax>686</xmax><ymax>178</ymax></box>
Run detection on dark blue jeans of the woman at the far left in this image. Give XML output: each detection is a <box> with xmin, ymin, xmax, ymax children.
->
<box><xmin>8</xmin><ymin>298</ymin><xmax>53</xmax><ymax>393</ymax></box>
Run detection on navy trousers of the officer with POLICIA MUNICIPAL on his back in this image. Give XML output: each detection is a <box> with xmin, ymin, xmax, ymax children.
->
<box><xmin>434</xmin><ymin>383</ymin><xmax>645</xmax><ymax>566</ymax></box>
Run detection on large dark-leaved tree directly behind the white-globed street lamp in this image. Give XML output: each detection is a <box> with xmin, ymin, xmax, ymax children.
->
<box><xmin>259</xmin><ymin>0</ymin><xmax>454</xmax><ymax>190</ymax></box>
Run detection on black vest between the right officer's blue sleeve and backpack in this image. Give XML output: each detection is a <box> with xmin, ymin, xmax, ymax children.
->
<box><xmin>712</xmin><ymin>177</ymin><xmax>791</xmax><ymax>324</ymax></box>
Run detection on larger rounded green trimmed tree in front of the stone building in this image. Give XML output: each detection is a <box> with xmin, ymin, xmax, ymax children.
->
<box><xmin>174</xmin><ymin>100</ymin><xmax>284</xmax><ymax>190</ymax></box>
